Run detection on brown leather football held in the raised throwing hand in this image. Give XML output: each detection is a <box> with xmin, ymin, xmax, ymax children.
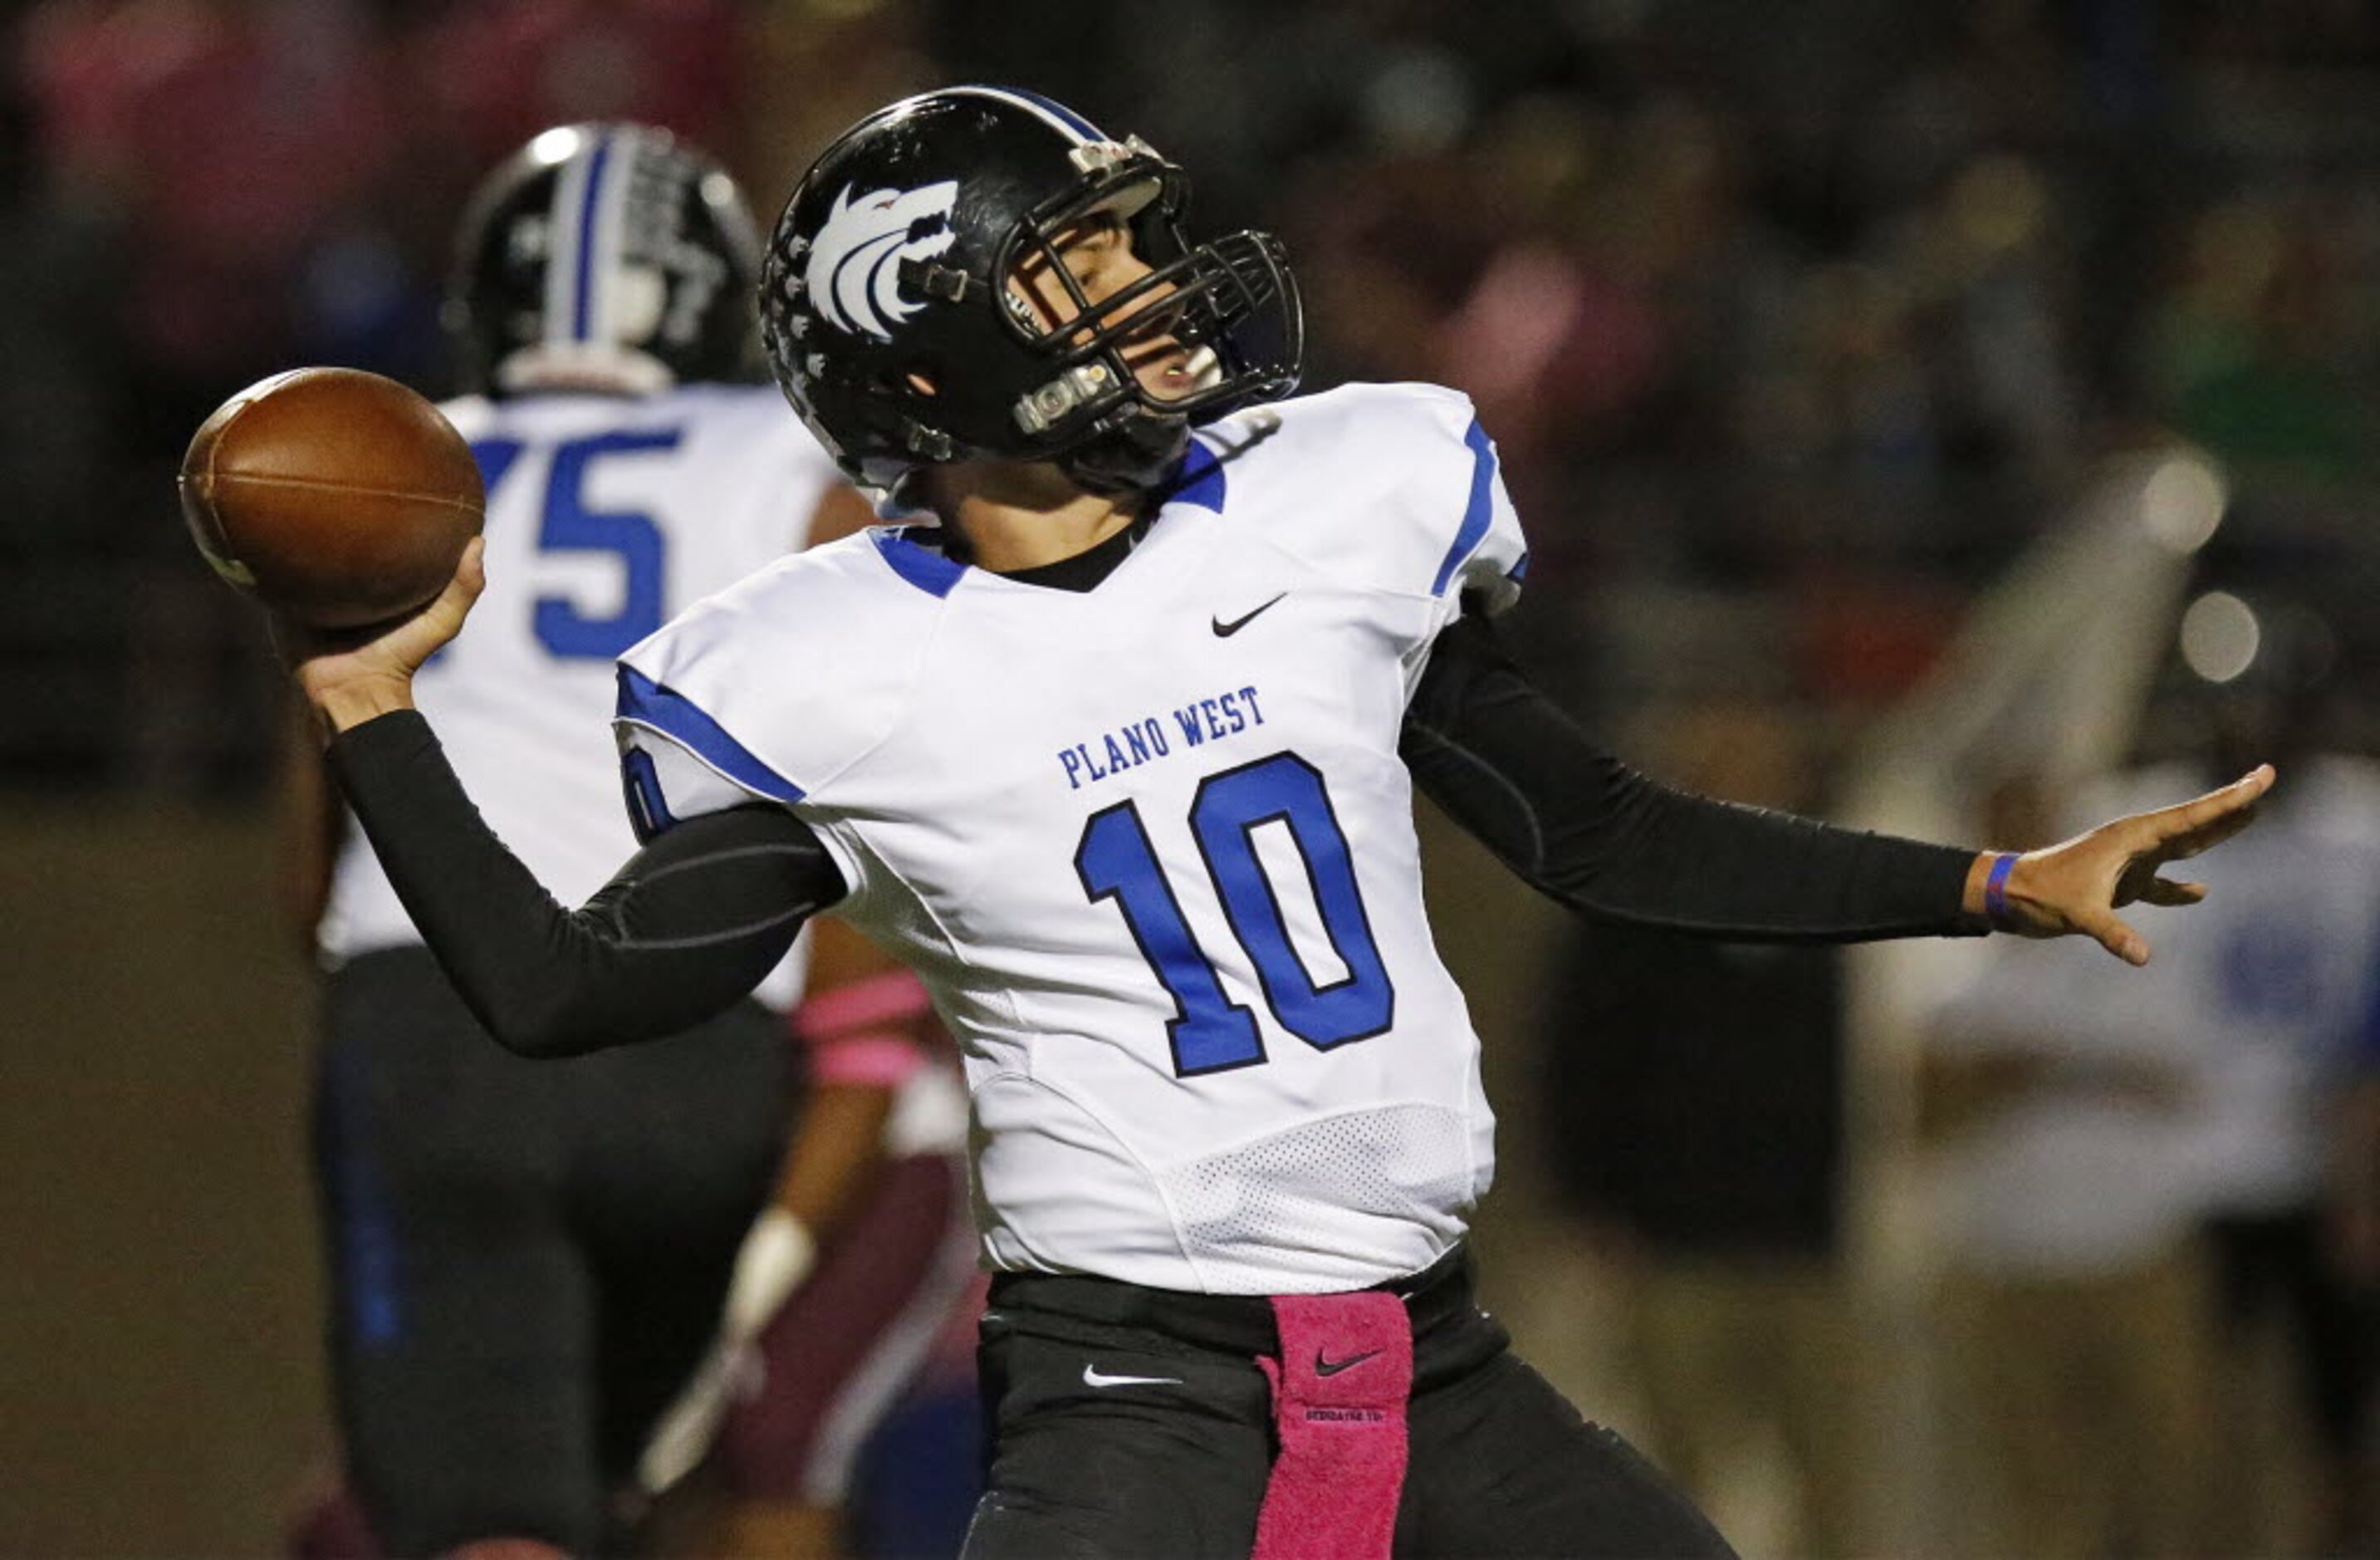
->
<box><xmin>181</xmin><ymin>369</ymin><xmax>483</xmax><ymax>629</ymax></box>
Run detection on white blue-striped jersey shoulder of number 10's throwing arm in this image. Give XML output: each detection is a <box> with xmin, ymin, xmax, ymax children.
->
<box><xmin>616</xmin><ymin>529</ymin><xmax>940</xmax><ymax>802</ymax></box>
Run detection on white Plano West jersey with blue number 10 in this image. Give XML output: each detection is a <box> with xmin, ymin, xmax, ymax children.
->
<box><xmin>619</xmin><ymin>385</ymin><xmax>1525</xmax><ymax>1293</ymax></box>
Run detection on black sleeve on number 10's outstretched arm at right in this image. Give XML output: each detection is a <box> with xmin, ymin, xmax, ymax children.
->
<box><xmin>1399</xmin><ymin>617</ymin><xmax>1985</xmax><ymax>943</ymax></box>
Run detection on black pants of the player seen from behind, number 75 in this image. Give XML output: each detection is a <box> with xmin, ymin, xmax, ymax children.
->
<box><xmin>314</xmin><ymin>948</ymin><xmax>800</xmax><ymax>1558</ymax></box>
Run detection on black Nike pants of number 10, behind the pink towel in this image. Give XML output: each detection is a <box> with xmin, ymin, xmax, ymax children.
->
<box><xmin>967</xmin><ymin>1253</ymin><xmax>1735</xmax><ymax>1560</ymax></box>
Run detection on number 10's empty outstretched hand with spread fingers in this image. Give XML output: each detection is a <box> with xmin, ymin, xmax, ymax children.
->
<box><xmin>1999</xmin><ymin>764</ymin><xmax>2273</xmax><ymax>964</ymax></box>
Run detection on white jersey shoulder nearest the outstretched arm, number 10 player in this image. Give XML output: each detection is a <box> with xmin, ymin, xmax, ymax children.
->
<box><xmin>1202</xmin><ymin>384</ymin><xmax>1525</xmax><ymax>598</ymax></box>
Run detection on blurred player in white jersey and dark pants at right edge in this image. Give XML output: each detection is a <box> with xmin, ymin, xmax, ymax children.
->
<box><xmin>2170</xmin><ymin>605</ymin><xmax>2380</xmax><ymax>1555</ymax></box>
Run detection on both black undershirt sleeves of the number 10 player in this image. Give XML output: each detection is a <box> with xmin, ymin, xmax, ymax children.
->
<box><xmin>331</xmin><ymin>619</ymin><xmax>1982</xmax><ymax>1055</ymax></box>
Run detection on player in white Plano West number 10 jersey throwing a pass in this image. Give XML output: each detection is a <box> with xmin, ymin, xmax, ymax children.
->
<box><xmin>293</xmin><ymin>88</ymin><xmax>2270</xmax><ymax>1558</ymax></box>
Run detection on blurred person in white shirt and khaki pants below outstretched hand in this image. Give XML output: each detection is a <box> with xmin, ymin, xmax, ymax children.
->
<box><xmin>1918</xmin><ymin>779</ymin><xmax>2230</xmax><ymax>1560</ymax></box>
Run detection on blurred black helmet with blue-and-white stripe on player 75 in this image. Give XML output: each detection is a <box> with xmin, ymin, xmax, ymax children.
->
<box><xmin>445</xmin><ymin>124</ymin><xmax>759</xmax><ymax>395</ymax></box>
